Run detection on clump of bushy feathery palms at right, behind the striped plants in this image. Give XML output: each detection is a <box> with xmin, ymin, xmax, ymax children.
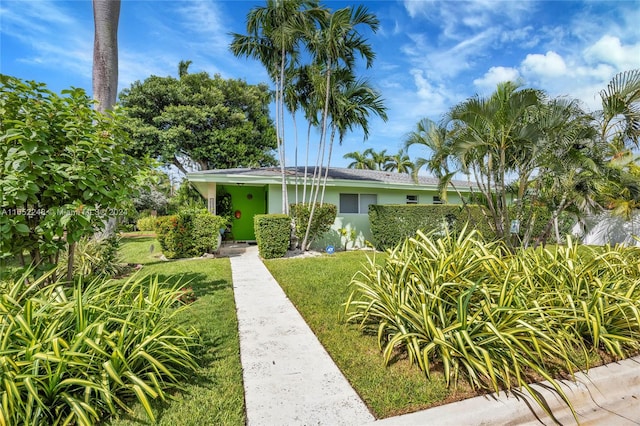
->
<box><xmin>406</xmin><ymin>70</ymin><xmax>640</xmax><ymax>246</ymax></box>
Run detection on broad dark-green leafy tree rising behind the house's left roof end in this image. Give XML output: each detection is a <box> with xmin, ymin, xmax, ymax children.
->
<box><xmin>120</xmin><ymin>62</ymin><xmax>276</xmax><ymax>174</ymax></box>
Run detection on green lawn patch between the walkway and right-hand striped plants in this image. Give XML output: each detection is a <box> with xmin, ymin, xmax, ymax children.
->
<box><xmin>264</xmin><ymin>251</ymin><xmax>470</xmax><ymax>418</ymax></box>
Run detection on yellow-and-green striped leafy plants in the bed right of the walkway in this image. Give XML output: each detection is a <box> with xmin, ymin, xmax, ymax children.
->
<box><xmin>346</xmin><ymin>232</ymin><xmax>640</xmax><ymax>420</ymax></box>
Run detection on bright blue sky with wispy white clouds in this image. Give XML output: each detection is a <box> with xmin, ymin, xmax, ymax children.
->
<box><xmin>0</xmin><ymin>0</ymin><xmax>640</xmax><ymax>170</ymax></box>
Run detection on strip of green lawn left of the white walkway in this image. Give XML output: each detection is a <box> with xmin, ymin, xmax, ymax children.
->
<box><xmin>107</xmin><ymin>237</ymin><xmax>245</xmax><ymax>426</ymax></box>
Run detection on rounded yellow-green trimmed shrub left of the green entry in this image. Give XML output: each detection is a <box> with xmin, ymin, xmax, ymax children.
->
<box><xmin>155</xmin><ymin>209</ymin><xmax>226</xmax><ymax>259</ymax></box>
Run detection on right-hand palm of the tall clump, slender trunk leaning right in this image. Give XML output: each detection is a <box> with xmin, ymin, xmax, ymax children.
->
<box><xmin>302</xmin><ymin>6</ymin><xmax>379</xmax><ymax>249</ymax></box>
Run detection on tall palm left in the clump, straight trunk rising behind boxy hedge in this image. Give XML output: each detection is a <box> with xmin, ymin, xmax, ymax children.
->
<box><xmin>230</xmin><ymin>0</ymin><xmax>326</xmax><ymax>213</ymax></box>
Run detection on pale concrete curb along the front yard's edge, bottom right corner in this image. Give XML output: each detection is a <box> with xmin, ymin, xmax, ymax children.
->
<box><xmin>370</xmin><ymin>356</ymin><xmax>640</xmax><ymax>426</ymax></box>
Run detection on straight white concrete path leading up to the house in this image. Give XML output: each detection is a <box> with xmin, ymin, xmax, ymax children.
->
<box><xmin>230</xmin><ymin>246</ymin><xmax>374</xmax><ymax>426</ymax></box>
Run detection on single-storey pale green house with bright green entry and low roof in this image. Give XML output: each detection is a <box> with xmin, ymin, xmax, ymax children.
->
<box><xmin>187</xmin><ymin>167</ymin><xmax>470</xmax><ymax>247</ymax></box>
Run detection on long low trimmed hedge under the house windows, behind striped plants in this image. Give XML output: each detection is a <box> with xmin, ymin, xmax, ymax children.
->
<box><xmin>369</xmin><ymin>204</ymin><xmax>495</xmax><ymax>250</ymax></box>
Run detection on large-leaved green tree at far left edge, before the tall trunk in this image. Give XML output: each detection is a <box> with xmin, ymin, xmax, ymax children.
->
<box><xmin>0</xmin><ymin>75</ymin><xmax>140</xmax><ymax>279</ymax></box>
